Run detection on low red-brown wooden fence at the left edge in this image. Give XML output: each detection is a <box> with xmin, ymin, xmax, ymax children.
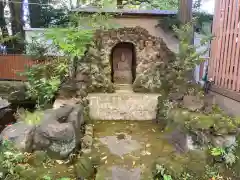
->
<box><xmin>0</xmin><ymin>55</ymin><xmax>34</xmax><ymax>81</ymax></box>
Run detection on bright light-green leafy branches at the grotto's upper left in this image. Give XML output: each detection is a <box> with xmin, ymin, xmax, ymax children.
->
<box><xmin>45</xmin><ymin>13</ymin><xmax>114</xmax><ymax>57</ymax></box>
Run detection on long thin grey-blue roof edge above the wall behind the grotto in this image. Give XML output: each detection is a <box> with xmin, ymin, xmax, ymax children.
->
<box><xmin>72</xmin><ymin>7</ymin><xmax>177</xmax><ymax>16</ymax></box>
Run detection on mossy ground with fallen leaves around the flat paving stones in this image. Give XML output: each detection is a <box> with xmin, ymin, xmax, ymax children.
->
<box><xmin>92</xmin><ymin>121</ymin><xmax>240</xmax><ymax>180</ymax></box>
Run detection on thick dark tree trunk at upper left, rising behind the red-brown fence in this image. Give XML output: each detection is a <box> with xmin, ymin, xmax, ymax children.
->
<box><xmin>9</xmin><ymin>0</ymin><xmax>25</xmax><ymax>54</ymax></box>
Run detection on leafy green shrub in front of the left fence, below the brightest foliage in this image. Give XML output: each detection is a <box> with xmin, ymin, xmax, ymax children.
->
<box><xmin>21</xmin><ymin>59</ymin><xmax>65</xmax><ymax>108</ymax></box>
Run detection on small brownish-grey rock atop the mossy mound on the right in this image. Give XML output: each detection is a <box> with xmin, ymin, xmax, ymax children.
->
<box><xmin>183</xmin><ymin>96</ymin><xmax>204</xmax><ymax>111</ymax></box>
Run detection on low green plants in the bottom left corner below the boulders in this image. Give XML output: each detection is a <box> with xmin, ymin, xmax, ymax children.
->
<box><xmin>0</xmin><ymin>140</ymin><xmax>73</xmax><ymax>180</ymax></box>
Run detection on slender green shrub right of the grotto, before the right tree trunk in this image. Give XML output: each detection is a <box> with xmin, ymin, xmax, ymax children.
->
<box><xmin>168</xmin><ymin>20</ymin><xmax>212</xmax><ymax>89</ymax></box>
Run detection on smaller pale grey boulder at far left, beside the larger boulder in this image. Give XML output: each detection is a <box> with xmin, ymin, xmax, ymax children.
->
<box><xmin>1</xmin><ymin>122</ymin><xmax>35</xmax><ymax>152</ymax></box>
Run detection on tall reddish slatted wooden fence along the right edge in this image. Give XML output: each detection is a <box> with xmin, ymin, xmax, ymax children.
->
<box><xmin>208</xmin><ymin>0</ymin><xmax>240</xmax><ymax>99</ymax></box>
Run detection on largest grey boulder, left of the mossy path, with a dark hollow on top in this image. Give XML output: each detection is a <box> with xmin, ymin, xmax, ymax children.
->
<box><xmin>33</xmin><ymin>104</ymin><xmax>84</xmax><ymax>159</ymax></box>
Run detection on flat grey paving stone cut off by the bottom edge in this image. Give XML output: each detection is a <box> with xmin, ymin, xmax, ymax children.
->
<box><xmin>112</xmin><ymin>166</ymin><xmax>141</xmax><ymax>180</ymax></box>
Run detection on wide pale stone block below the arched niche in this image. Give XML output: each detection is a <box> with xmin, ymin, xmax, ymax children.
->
<box><xmin>88</xmin><ymin>91</ymin><xmax>159</xmax><ymax>120</ymax></box>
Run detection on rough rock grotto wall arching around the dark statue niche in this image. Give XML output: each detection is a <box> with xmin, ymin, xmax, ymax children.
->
<box><xmin>76</xmin><ymin>27</ymin><xmax>175</xmax><ymax>94</ymax></box>
